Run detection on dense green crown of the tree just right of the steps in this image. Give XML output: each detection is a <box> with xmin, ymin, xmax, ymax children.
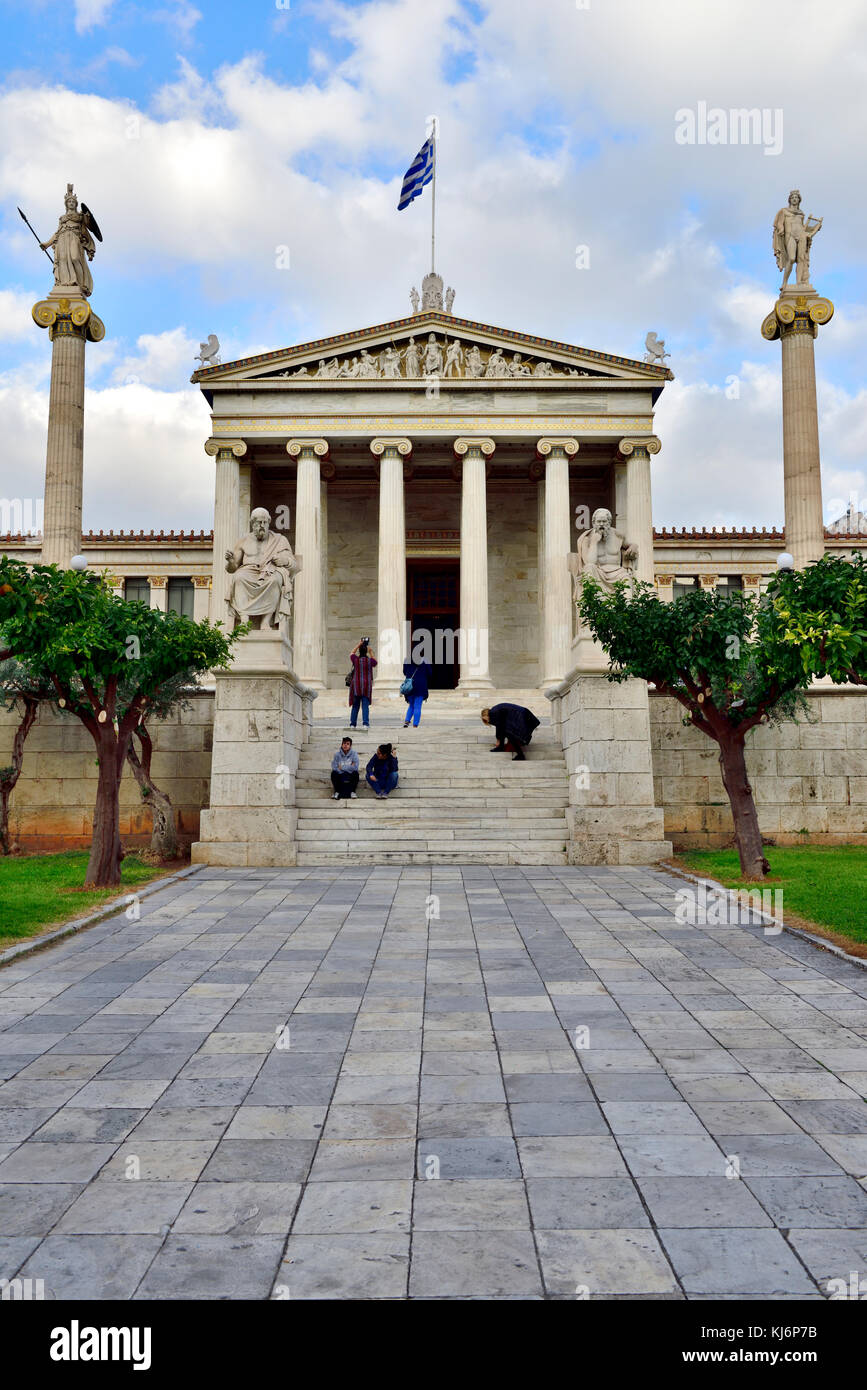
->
<box><xmin>581</xmin><ymin>578</ymin><xmax>807</xmax><ymax>738</ymax></box>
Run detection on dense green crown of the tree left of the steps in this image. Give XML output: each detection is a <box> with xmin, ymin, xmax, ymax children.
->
<box><xmin>0</xmin><ymin>556</ymin><xmax>238</xmax><ymax>731</ymax></box>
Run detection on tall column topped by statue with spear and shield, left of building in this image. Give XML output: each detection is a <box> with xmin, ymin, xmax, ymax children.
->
<box><xmin>31</xmin><ymin>183</ymin><xmax>106</xmax><ymax>569</ymax></box>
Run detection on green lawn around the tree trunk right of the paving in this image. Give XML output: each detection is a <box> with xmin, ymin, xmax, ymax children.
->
<box><xmin>677</xmin><ymin>845</ymin><xmax>867</xmax><ymax>955</ymax></box>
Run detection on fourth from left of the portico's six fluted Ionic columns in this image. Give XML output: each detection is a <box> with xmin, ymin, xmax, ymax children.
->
<box><xmin>454</xmin><ymin>436</ymin><xmax>495</xmax><ymax>691</ymax></box>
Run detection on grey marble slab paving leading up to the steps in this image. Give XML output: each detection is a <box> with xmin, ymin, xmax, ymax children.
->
<box><xmin>0</xmin><ymin>867</ymin><xmax>867</xmax><ymax>1300</ymax></box>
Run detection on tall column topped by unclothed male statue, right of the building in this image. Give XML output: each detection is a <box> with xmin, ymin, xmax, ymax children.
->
<box><xmin>761</xmin><ymin>189</ymin><xmax>834</xmax><ymax>570</ymax></box>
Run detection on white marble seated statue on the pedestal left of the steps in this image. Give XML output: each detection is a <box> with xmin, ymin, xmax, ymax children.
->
<box><xmin>225</xmin><ymin>507</ymin><xmax>302</xmax><ymax>628</ymax></box>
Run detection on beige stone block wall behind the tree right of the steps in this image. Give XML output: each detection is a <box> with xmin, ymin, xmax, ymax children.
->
<box><xmin>650</xmin><ymin>688</ymin><xmax>867</xmax><ymax>848</ymax></box>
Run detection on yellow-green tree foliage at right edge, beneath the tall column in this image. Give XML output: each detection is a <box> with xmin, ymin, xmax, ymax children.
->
<box><xmin>768</xmin><ymin>555</ymin><xmax>867</xmax><ymax>685</ymax></box>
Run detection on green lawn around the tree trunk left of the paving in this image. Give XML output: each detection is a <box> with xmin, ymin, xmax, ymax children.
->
<box><xmin>0</xmin><ymin>849</ymin><xmax>165</xmax><ymax>948</ymax></box>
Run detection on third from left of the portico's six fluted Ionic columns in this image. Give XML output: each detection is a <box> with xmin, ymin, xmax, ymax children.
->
<box><xmin>371</xmin><ymin>438</ymin><xmax>413</xmax><ymax>694</ymax></box>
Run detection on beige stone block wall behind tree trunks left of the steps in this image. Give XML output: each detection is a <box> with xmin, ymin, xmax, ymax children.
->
<box><xmin>0</xmin><ymin>692</ymin><xmax>214</xmax><ymax>851</ymax></box>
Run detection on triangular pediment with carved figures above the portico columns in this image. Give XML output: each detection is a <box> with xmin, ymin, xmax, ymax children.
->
<box><xmin>192</xmin><ymin>310</ymin><xmax>671</xmax><ymax>392</ymax></box>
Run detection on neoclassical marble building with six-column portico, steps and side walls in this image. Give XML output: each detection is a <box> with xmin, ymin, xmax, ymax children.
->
<box><xmin>0</xmin><ymin>265</ymin><xmax>867</xmax><ymax>863</ymax></box>
